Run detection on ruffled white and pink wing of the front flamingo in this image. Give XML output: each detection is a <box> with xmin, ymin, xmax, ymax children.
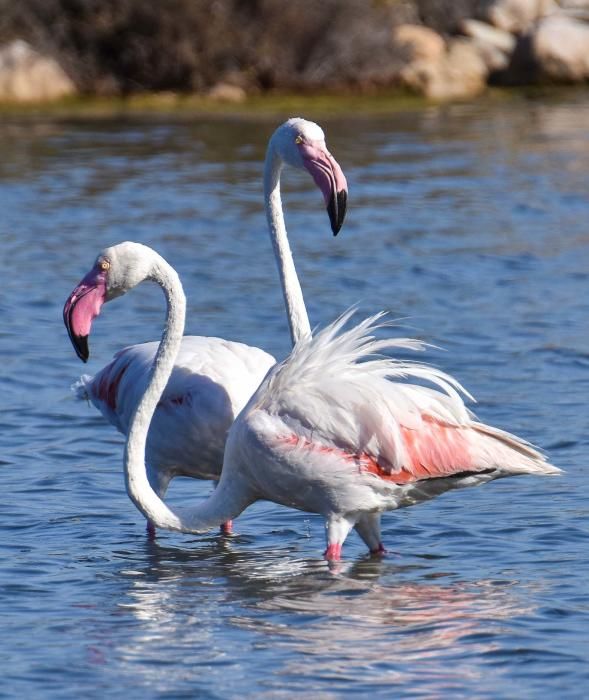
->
<box><xmin>250</xmin><ymin>314</ymin><xmax>558</xmax><ymax>484</ymax></box>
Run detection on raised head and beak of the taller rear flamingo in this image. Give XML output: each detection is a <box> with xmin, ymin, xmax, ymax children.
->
<box><xmin>270</xmin><ymin>117</ymin><xmax>348</xmax><ymax>236</ymax></box>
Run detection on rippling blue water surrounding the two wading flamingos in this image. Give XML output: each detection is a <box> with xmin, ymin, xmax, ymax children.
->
<box><xmin>0</xmin><ymin>97</ymin><xmax>589</xmax><ymax>700</ymax></box>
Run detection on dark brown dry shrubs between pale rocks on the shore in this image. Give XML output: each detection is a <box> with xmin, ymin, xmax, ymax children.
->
<box><xmin>0</xmin><ymin>0</ymin><xmax>422</xmax><ymax>94</ymax></box>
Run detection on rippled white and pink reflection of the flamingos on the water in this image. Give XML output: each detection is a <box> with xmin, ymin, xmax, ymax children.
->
<box><xmin>112</xmin><ymin>542</ymin><xmax>533</xmax><ymax>693</ymax></box>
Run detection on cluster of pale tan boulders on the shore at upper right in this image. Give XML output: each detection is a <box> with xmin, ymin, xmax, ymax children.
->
<box><xmin>393</xmin><ymin>0</ymin><xmax>589</xmax><ymax>101</ymax></box>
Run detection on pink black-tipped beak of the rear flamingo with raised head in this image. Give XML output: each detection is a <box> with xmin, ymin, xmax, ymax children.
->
<box><xmin>298</xmin><ymin>141</ymin><xmax>348</xmax><ymax>236</ymax></box>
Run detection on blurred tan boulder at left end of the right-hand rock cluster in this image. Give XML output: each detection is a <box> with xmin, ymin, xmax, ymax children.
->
<box><xmin>400</xmin><ymin>39</ymin><xmax>489</xmax><ymax>102</ymax></box>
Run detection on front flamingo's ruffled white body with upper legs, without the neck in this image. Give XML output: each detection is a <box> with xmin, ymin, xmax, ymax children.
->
<box><xmin>220</xmin><ymin>312</ymin><xmax>560</xmax><ymax>559</ymax></box>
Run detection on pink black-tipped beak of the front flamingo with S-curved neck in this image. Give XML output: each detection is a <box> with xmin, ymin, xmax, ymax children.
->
<box><xmin>63</xmin><ymin>267</ymin><xmax>106</xmax><ymax>362</ymax></box>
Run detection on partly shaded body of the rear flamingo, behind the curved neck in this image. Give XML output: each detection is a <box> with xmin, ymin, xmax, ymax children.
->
<box><xmin>75</xmin><ymin>336</ymin><xmax>275</xmax><ymax>479</ymax></box>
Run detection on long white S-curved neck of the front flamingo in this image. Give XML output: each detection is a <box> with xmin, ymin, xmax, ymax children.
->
<box><xmin>124</xmin><ymin>258</ymin><xmax>247</xmax><ymax>532</ymax></box>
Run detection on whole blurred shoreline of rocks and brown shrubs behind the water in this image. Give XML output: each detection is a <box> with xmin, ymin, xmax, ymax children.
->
<box><xmin>0</xmin><ymin>0</ymin><xmax>589</xmax><ymax>102</ymax></box>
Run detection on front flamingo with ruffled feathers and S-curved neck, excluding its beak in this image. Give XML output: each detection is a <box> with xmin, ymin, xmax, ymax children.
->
<box><xmin>66</xmin><ymin>242</ymin><xmax>560</xmax><ymax>561</ymax></box>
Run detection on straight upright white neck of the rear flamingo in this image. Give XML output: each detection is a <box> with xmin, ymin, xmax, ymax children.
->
<box><xmin>264</xmin><ymin>143</ymin><xmax>311</xmax><ymax>345</ymax></box>
